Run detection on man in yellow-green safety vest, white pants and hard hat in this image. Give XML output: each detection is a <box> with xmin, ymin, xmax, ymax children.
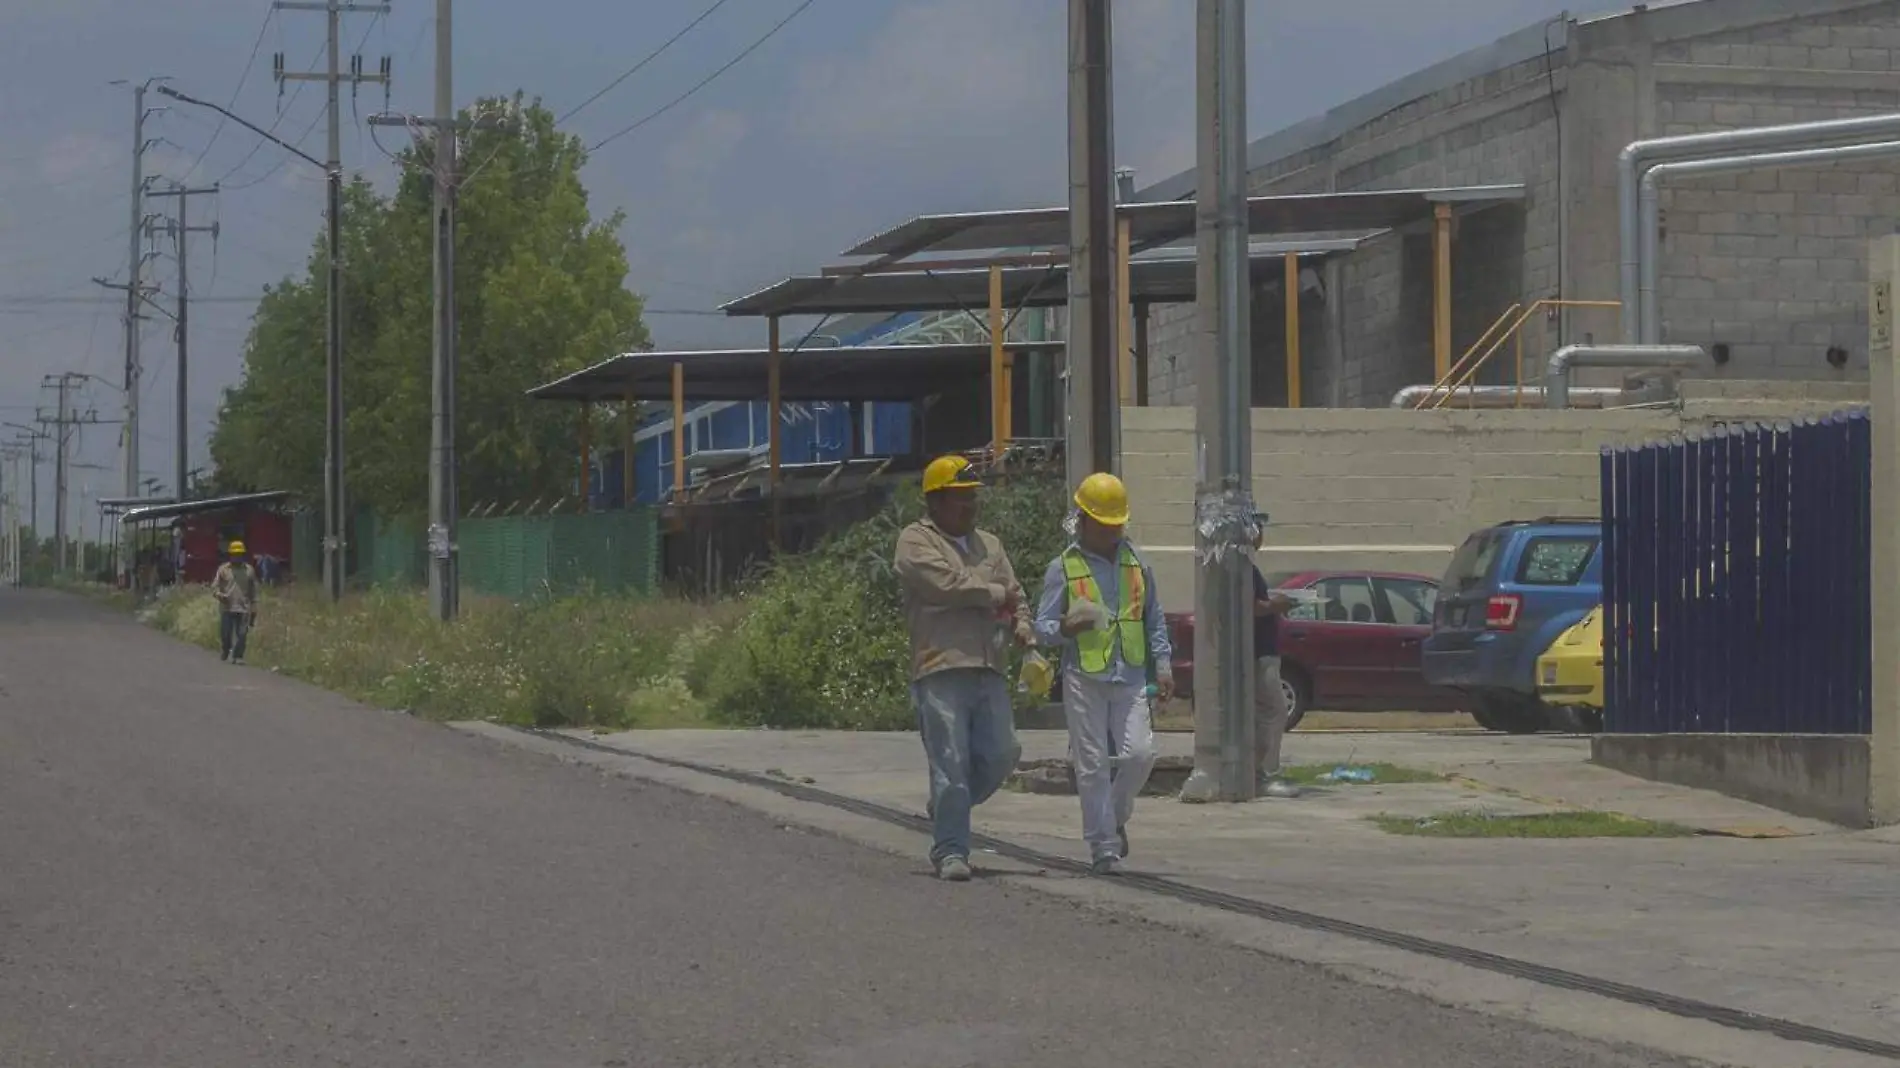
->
<box><xmin>1036</xmin><ymin>471</ymin><xmax>1174</xmax><ymax>874</ymax></box>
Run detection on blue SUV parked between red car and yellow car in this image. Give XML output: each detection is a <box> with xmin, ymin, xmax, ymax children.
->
<box><xmin>1425</xmin><ymin>519</ymin><xmax>1604</xmax><ymax>734</ymax></box>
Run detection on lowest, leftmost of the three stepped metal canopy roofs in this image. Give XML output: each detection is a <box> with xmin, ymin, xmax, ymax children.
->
<box><xmin>528</xmin><ymin>340</ymin><xmax>1062</xmax><ymax>405</ymax></box>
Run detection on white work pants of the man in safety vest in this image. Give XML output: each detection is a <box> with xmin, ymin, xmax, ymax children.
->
<box><xmin>1062</xmin><ymin>671</ymin><xmax>1155</xmax><ymax>861</ymax></box>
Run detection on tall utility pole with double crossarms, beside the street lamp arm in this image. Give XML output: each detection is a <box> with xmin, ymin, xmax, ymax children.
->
<box><xmin>272</xmin><ymin>0</ymin><xmax>390</xmax><ymax>601</ymax></box>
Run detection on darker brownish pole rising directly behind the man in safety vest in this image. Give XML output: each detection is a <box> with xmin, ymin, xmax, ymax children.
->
<box><xmin>1064</xmin><ymin>0</ymin><xmax>1121</xmax><ymax>486</ymax></box>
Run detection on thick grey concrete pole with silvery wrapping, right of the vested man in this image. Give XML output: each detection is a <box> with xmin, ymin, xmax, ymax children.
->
<box><xmin>1182</xmin><ymin>0</ymin><xmax>1260</xmax><ymax>802</ymax></box>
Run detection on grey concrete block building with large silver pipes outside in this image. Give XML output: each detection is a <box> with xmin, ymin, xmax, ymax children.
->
<box><xmin>1136</xmin><ymin>0</ymin><xmax>1900</xmax><ymax>407</ymax></box>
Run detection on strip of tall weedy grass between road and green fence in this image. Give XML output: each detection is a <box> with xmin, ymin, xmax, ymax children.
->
<box><xmin>144</xmin><ymin>587</ymin><xmax>735</xmax><ymax>730</ymax></box>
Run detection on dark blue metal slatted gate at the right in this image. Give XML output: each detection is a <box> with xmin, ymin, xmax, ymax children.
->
<box><xmin>1602</xmin><ymin>412</ymin><xmax>1873</xmax><ymax>734</ymax></box>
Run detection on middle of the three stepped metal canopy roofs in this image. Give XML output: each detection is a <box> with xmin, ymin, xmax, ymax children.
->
<box><xmin>720</xmin><ymin>238</ymin><xmax>1362</xmax><ymax>319</ymax></box>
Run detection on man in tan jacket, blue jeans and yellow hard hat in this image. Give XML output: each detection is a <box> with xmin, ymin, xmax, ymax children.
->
<box><xmin>897</xmin><ymin>456</ymin><xmax>1032</xmax><ymax>882</ymax></box>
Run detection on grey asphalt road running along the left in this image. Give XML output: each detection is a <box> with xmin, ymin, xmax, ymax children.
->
<box><xmin>0</xmin><ymin>591</ymin><xmax>1694</xmax><ymax>1068</ymax></box>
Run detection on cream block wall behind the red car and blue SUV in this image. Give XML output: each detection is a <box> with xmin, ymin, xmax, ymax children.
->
<box><xmin>1123</xmin><ymin>409</ymin><xmax>1682</xmax><ymax>612</ymax></box>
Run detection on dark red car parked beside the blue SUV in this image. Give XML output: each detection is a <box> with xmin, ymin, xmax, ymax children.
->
<box><xmin>1169</xmin><ymin>572</ymin><xmax>1459</xmax><ymax>730</ymax></box>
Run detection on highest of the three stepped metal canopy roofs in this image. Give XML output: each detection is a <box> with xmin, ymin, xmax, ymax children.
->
<box><xmin>844</xmin><ymin>184</ymin><xmax>1524</xmax><ymax>260</ymax></box>
